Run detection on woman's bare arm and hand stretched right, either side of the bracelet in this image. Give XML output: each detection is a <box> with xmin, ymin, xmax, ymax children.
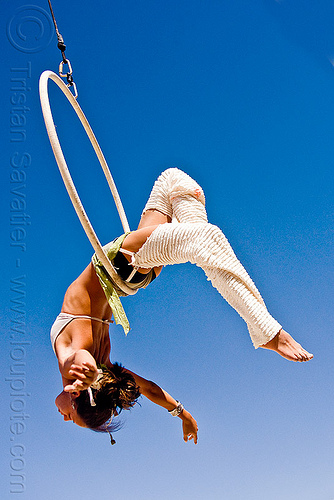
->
<box><xmin>127</xmin><ymin>370</ymin><xmax>198</xmax><ymax>444</ymax></box>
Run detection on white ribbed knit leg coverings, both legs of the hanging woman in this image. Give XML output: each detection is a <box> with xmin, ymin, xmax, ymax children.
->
<box><xmin>133</xmin><ymin>168</ymin><xmax>281</xmax><ymax>348</ymax></box>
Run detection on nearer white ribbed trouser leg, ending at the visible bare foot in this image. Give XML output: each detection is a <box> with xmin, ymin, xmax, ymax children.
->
<box><xmin>130</xmin><ymin>222</ymin><xmax>281</xmax><ymax>347</ymax></box>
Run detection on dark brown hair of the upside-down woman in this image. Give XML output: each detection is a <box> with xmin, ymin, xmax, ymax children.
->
<box><xmin>75</xmin><ymin>363</ymin><xmax>140</xmax><ymax>434</ymax></box>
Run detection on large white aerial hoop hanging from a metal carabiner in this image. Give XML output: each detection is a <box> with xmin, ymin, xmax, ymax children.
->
<box><xmin>39</xmin><ymin>71</ymin><xmax>137</xmax><ymax>295</ymax></box>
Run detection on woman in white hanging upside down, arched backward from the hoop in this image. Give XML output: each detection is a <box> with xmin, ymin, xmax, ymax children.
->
<box><xmin>51</xmin><ymin>168</ymin><xmax>313</xmax><ymax>443</ymax></box>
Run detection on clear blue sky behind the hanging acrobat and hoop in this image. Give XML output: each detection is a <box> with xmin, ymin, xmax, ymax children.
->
<box><xmin>0</xmin><ymin>0</ymin><xmax>334</xmax><ymax>500</ymax></box>
